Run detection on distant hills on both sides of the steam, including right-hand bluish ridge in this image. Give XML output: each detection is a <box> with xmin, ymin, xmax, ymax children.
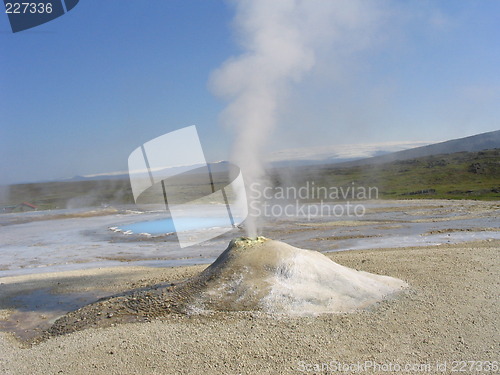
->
<box><xmin>4</xmin><ymin>131</ymin><xmax>500</xmax><ymax>209</ymax></box>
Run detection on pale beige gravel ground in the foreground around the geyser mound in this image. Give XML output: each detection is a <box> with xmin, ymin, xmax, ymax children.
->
<box><xmin>0</xmin><ymin>240</ymin><xmax>500</xmax><ymax>375</ymax></box>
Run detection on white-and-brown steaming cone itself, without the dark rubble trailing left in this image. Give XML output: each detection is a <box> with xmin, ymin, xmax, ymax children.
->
<box><xmin>181</xmin><ymin>237</ymin><xmax>406</xmax><ymax>315</ymax></box>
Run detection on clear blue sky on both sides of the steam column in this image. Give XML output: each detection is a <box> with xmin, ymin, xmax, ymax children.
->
<box><xmin>0</xmin><ymin>0</ymin><xmax>500</xmax><ymax>184</ymax></box>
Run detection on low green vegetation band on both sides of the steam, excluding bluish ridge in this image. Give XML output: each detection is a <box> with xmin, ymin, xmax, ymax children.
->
<box><xmin>0</xmin><ymin>149</ymin><xmax>500</xmax><ymax>212</ymax></box>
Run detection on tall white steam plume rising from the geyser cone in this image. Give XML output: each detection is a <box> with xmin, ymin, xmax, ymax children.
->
<box><xmin>211</xmin><ymin>0</ymin><xmax>386</xmax><ymax>237</ymax></box>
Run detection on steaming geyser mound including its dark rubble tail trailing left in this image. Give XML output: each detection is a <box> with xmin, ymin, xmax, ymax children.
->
<box><xmin>44</xmin><ymin>237</ymin><xmax>406</xmax><ymax>340</ymax></box>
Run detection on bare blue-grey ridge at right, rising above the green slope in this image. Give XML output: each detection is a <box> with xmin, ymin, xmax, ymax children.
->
<box><xmin>338</xmin><ymin>130</ymin><xmax>500</xmax><ymax>167</ymax></box>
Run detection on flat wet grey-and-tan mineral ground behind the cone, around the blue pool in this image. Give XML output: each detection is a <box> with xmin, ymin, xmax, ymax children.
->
<box><xmin>0</xmin><ymin>200</ymin><xmax>500</xmax><ymax>277</ymax></box>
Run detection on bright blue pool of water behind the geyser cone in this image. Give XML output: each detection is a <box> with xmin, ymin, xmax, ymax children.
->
<box><xmin>120</xmin><ymin>217</ymin><xmax>231</xmax><ymax>234</ymax></box>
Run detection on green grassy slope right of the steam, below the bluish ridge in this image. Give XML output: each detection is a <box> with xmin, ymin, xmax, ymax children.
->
<box><xmin>282</xmin><ymin>149</ymin><xmax>500</xmax><ymax>200</ymax></box>
